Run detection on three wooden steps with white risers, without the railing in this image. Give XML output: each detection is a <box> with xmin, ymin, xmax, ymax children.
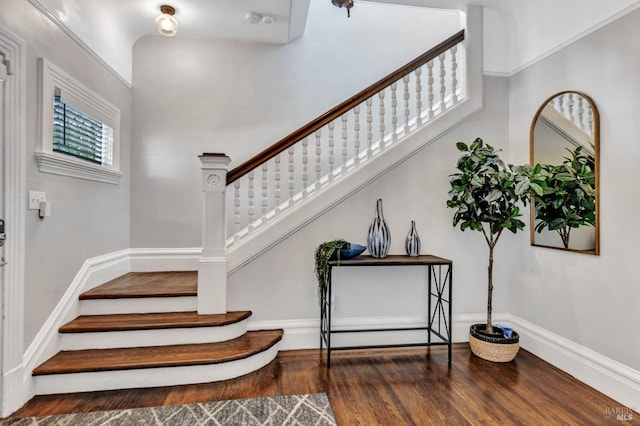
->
<box><xmin>33</xmin><ymin>272</ymin><xmax>283</xmax><ymax>394</ymax></box>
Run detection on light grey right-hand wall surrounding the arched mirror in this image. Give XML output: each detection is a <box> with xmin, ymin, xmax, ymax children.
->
<box><xmin>509</xmin><ymin>6</ymin><xmax>640</xmax><ymax>370</ymax></box>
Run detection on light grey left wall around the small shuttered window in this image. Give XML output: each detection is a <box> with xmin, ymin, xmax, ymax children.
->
<box><xmin>0</xmin><ymin>0</ymin><xmax>131</xmax><ymax>347</ymax></box>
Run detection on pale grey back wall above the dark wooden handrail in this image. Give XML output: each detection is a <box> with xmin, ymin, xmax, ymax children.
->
<box><xmin>131</xmin><ymin>0</ymin><xmax>461</xmax><ymax>247</ymax></box>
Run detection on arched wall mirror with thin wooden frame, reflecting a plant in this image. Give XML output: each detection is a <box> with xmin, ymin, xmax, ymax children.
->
<box><xmin>530</xmin><ymin>91</ymin><xmax>600</xmax><ymax>255</ymax></box>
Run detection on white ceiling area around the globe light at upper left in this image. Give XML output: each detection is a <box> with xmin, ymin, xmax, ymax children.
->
<box><xmin>29</xmin><ymin>0</ymin><xmax>312</xmax><ymax>84</ymax></box>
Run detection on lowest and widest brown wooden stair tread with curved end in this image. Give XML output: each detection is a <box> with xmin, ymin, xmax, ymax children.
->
<box><xmin>33</xmin><ymin>330</ymin><xmax>284</xmax><ymax>376</ymax></box>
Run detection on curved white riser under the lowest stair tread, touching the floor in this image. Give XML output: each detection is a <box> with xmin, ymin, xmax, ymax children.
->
<box><xmin>34</xmin><ymin>344</ymin><xmax>278</xmax><ymax>395</ymax></box>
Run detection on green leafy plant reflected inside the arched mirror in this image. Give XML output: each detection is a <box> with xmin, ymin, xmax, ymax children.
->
<box><xmin>529</xmin><ymin>146</ymin><xmax>596</xmax><ymax>248</ymax></box>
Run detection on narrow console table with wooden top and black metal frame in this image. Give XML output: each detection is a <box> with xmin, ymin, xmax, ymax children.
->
<box><xmin>320</xmin><ymin>255</ymin><xmax>453</xmax><ymax>368</ymax></box>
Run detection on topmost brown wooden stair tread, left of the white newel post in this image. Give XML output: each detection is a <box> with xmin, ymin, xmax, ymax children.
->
<box><xmin>80</xmin><ymin>271</ymin><xmax>198</xmax><ymax>300</ymax></box>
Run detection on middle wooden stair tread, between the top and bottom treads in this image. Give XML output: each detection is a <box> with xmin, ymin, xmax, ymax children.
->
<box><xmin>59</xmin><ymin>311</ymin><xmax>251</xmax><ymax>333</ymax></box>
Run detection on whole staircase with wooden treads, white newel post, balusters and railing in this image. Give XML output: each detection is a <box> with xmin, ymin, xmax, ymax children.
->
<box><xmin>28</xmin><ymin>7</ymin><xmax>482</xmax><ymax>394</ymax></box>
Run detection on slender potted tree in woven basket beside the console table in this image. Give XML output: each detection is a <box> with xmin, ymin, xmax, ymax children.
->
<box><xmin>447</xmin><ymin>138</ymin><xmax>531</xmax><ymax>362</ymax></box>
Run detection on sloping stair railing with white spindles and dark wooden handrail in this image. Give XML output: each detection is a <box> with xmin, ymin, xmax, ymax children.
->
<box><xmin>226</xmin><ymin>31</ymin><xmax>466</xmax><ymax>248</ymax></box>
